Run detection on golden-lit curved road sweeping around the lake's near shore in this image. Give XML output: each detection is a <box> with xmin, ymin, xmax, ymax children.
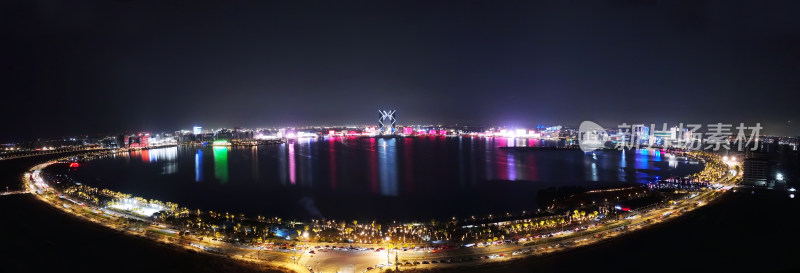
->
<box><xmin>23</xmin><ymin>155</ymin><xmax>736</xmax><ymax>272</ymax></box>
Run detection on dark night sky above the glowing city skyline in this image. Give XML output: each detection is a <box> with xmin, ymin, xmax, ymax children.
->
<box><xmin>0</xmin><ymin>0</ymin><xmax>800</xmax><ymax>141</ymax></box>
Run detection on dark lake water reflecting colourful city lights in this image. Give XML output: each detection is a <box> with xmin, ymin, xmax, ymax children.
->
<box><xmin>74</xmin><ymin>137</ymin><xmax>702</xmax><ymax>221</ymax></box>
